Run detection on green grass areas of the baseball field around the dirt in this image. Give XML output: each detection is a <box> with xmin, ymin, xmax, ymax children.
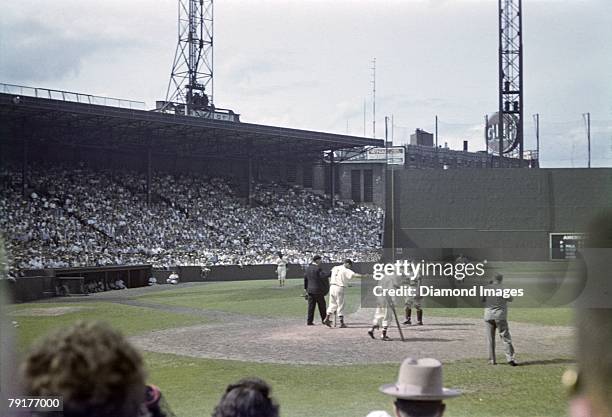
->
<box><xmin>10</xmin><ymin>280</ymin><xmax>572</xmax><ymax>417</ymax></box>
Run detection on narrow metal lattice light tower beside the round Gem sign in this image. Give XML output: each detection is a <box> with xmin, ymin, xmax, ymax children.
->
<box><xmin>498</xmin><ymin>0</ymin><xmax>523</xmax><ymax>159</ymax></box>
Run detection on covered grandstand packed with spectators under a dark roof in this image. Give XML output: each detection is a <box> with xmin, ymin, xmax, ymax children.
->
<box><xmin>0</xmin><ymin>84</ymin><xmax>383</xmax><ymax>278</ymax></box>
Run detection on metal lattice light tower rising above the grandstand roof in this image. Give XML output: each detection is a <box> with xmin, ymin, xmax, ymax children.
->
<box><xmin>166</xmin><ymin>0</ymin><xmax>213</xmax><ymax>114</ymax></box>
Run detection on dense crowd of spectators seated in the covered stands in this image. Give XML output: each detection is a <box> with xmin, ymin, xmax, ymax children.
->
<box><xmin>0</xmin><ymin>166</ymin><xmax>383</xmax><ymax>270</ymax></box>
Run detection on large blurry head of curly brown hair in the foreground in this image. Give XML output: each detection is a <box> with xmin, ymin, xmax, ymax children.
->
<box><xmin>22</xmin><ymin>321</ymin><xmax>145</xmax><ymax>417</ymax></box>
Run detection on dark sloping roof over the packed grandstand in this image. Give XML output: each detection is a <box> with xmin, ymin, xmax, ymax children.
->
<box><xmin>0</xmin><ymin>90</ymin><xmax>384</xmax><ymax>160</ymax></box>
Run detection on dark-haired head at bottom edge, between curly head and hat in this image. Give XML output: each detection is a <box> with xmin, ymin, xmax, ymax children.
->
<box><xmin>212</xmin><ymin>378</ymin><xmax>279</xmax><ymax>417</ymax></box>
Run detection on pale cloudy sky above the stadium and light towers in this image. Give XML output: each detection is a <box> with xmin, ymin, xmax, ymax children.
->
<box><xmin>0</xmin><ymin>0</ymin><xmax>612</xmax><ymax>167</ymax></box>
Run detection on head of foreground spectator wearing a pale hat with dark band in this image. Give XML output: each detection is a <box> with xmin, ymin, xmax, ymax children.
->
<box><xmin>379</xmin><ymin>358</ymin><xmax>461</xmax><ymax>417</ymax></box>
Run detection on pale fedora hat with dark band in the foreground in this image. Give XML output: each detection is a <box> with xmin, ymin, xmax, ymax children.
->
<box><xmin>379</xmin><ymin>358</ymin><xmax>461</xmax><ymax>401</ymax></box>
